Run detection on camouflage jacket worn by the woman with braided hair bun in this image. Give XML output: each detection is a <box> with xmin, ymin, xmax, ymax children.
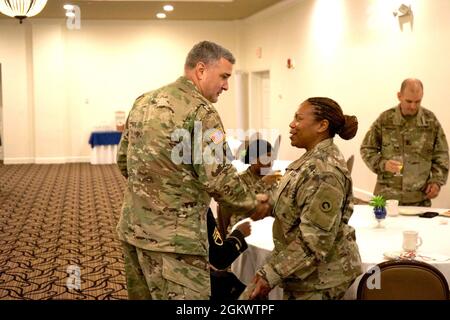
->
<box><xmin>258</xmin><ymin>139</ymin><xmax>362</xmax><ymax>291</ymax></box>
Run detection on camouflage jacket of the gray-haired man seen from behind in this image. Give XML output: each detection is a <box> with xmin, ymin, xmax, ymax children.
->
<box><xmin>117</xmin><ymin>77</ymin><xmax>256</xmax><ymax>256</ymax></box>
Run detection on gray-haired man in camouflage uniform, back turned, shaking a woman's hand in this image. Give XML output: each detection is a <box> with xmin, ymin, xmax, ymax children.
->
<box><xmin>117</xmin><ymin>41</ymin><xmax>269</xmax><ymax>299</ymax></box>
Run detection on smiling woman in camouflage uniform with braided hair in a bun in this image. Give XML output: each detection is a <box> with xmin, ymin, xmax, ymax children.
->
<box><xmin>250</xmin><ymin>98</ymin><xmax>362</xmax><ymax>299</ymax></box>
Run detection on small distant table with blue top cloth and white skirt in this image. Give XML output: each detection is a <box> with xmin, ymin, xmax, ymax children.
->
<box><xmin>89</xmin><ymin>131</ymin><xmax>122</xmax><ymax>164</ymax></box>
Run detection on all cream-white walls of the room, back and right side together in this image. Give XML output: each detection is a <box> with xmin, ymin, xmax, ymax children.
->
<box><xmin>0</xmin><ymin>0</ymin><xmax>450</xmax><ymax>207</ymax></box>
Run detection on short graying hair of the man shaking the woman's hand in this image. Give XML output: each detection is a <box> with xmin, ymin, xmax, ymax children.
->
<box><xmin>184</xmin><ymin>41</ymin><xmax>236</xmax><ymax>69</ymax></box>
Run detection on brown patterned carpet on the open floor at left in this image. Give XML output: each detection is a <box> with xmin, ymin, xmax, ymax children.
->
<box><xmin>0</xmin><ymin>163</ymin><xmax>127</xmax><ymax>300</ymax></box>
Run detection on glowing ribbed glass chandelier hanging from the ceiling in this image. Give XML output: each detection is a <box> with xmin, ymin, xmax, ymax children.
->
<box><xmin>0</xmin><ymin>0</ymin><xmax>47</xmax><ymax>23</ymax></box>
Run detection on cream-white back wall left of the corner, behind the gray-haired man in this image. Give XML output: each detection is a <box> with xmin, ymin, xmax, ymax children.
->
<box><xmin>0</xmin><ymin>19</ymin><xmax>239</xmax><ymax>163</ymax></box>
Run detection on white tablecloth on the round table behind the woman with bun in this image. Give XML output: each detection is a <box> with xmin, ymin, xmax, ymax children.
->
<box><xmin>232</xmin><ymin>205</ymin><xmax>450</xmax><ymax>299</ymax></box>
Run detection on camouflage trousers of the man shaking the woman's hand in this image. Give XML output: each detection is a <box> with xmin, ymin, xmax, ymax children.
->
<box><xmin>122</xmin><ymin>242</ymin><xmax>211</xmax><ymax>300</ymax></box>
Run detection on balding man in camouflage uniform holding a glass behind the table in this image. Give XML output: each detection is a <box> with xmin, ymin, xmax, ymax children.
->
<box><xmin>361</xmin><ymin>79</ymin><xmax>449</xmax><ymax>207</ymax></box>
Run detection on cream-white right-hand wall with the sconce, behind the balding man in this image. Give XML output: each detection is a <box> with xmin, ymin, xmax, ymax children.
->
<box><xmin>240</xmin><ymin>0</ymin><xmax>450</xmax><ymax>208</ymax></box>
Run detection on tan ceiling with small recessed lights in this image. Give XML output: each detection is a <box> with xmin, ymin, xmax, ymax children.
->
<box><xmin>0</xmin><ymin>0</ymin><xmax>284</xmax><ymax>20</ymax></box>
